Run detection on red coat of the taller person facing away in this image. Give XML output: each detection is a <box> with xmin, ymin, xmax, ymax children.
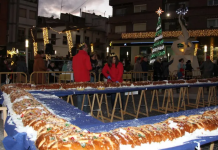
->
<box><xmin>72</xmin><ymin>50</ymin><xmax>92</xmax><ymax>82</ymax></box>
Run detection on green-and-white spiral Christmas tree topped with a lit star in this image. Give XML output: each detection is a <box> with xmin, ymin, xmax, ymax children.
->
<box><xmin>150</xmin><ymin>7</ymin><xmax>165</xmax><ymax>64</ymax></box>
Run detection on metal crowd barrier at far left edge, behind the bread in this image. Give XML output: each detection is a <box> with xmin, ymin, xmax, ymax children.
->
<box><xmin>0</xmin><ymin>72</ymin><xmax>27</xmax><ymax>86</ymax></box>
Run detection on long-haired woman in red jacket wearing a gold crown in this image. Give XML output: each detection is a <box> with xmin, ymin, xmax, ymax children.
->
<box><xmin>102</xmin><ymin>56</ymin><xmax>123</xmax><ymax>107</ymax></box>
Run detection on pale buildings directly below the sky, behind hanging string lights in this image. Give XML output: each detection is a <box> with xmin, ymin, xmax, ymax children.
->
<box><xmin>37</xmin><ymin>12</ymin><xmax>108</xmax><ymax>57</ymax></box>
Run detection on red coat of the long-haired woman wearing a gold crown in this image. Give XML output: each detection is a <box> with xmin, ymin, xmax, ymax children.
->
<box><xmin>102</xmin><ymin>62</ymin><xmax>123</xmax><ymax>82</ymax></box>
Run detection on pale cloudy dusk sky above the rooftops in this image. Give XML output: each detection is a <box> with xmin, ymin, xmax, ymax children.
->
<box><xmin>39</xmin><ymin>0</ymin><xmax>112</xmax><ymax>18</ymax></box>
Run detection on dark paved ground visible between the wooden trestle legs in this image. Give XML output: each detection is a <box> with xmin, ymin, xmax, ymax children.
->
<box><xmin>0</xmin><ymin>88</ymin><xmax>218</xmax><ymax>150</ymax></box>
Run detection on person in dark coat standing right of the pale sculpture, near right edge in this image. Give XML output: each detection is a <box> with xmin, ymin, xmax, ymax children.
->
<box><xmin>199</xmin><ymin>56</ymin><xmax>214</xmax><ymax>78</ymax></box>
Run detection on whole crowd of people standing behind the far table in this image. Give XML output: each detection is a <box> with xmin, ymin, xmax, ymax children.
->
<box><xmin>0</xmin><ymin>44</ymin><xmax>218</xmax><ymax>111</ymax></box>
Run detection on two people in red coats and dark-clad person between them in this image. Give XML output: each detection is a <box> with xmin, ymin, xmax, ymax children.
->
<box><xmin>72</xmin><ymin>44</ymin><xmax>124</xmax><ymax>112</ymax></box>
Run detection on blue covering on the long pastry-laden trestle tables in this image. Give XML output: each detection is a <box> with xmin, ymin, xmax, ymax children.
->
<box><xmin>3</xmin><ymin>83</ymin><xmax>218</xmax><ymax>150</ymax></box>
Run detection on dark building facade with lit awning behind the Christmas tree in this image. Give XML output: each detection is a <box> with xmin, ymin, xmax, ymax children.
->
<box><xmin>108</xmin><ymin>0</ymin><xmax>218</xmax><ymax>64</ymax></box>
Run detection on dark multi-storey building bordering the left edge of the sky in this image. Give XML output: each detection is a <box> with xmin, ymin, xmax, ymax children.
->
<box><xmin>7</xmin><ymin>0</ymin><xmax>38</xmax><ymax>56</ymax></box>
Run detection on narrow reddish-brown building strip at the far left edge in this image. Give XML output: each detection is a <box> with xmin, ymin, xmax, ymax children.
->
<box><xmin>0</xmin><ymin>0</ymin><xmax>8</xmax><ymax>55</ymax></box>
